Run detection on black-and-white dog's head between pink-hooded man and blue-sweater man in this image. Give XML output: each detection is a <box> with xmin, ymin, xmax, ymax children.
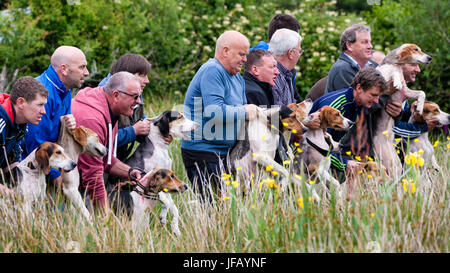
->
<box><xmin>151</xmin><ymin>110</ymin><xmax>200</xmax><ymax>140</ymax></box>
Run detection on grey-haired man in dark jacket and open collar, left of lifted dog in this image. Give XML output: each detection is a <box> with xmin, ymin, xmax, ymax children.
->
<box><xmin>325</xmin><ymin>24</ymin><xmax>377</xmax><ymax>94</ymax></box>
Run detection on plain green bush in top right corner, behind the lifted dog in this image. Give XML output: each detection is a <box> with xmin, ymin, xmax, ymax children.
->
<box><xmin>364</xmin><ymin>0</ymin><xmax>450</xmax><ymax>111</ymax></box>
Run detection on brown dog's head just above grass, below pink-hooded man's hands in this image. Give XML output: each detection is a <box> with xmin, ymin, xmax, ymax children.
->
<box><xmin>147</xmin><ymin>168</ymin><xmax>188</xmax><ymax>193</ymax></box>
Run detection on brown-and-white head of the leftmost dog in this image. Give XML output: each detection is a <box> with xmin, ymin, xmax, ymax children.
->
<box><xmin>34</xmin><ymin>142</ymin><xmax>77</xmax><ymax>174</ymax></box>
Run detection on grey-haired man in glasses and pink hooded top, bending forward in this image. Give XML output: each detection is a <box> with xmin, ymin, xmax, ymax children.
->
<box><xmin>72</xmin><ymin>72</ymin><xmax>142</xmax><ymax>209</ymax></box>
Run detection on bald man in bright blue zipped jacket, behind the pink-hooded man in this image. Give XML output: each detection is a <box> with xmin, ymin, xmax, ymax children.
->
<box><xmin>23</xmin><ymin>46</ymin><xmax>89</xmax><ymax>179</ymax></box>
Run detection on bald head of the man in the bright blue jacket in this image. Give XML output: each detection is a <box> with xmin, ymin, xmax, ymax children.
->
<box><xmin>50</xmin><ymin>46</ymin><xmax>89</xmax><ymax>90</ymax></box>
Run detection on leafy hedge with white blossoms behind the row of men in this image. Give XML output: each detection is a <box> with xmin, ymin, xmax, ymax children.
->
<box><xmin>0</xmin><ymin>0</ymin><xmax>448</xmax><ymax>110</ymax></box>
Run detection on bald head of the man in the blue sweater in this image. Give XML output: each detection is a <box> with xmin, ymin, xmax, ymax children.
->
<box><xmin>214</xmin><ymin>30</ymin><xmax>250</xmax><ymax>75</ymax></box>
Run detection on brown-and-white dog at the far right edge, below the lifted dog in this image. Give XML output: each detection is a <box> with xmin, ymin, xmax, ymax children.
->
<box><xmin>409</xmin><ymin>101</ymin><xmax>450</xmax><ymax>170</ymax></box>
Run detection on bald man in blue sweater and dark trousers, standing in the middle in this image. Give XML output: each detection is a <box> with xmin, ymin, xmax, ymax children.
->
<box><xmin>181</xmin><ymin>31</ymin><xmax>256</xmax><ymax>201</ymax></box>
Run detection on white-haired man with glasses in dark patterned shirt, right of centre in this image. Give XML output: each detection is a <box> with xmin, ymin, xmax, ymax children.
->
<box><xmin>269</xmin><ymin>28</ymin><xmax>303</xmax><ymax>105</ymax></box>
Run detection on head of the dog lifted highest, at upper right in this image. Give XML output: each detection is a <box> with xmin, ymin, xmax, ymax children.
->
<box><xmin>381</xmin><ymin>44</ymin><xmax>431</xmax><ymax>64</ymax></box>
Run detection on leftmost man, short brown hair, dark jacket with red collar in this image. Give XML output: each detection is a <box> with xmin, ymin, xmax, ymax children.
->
<box><xmin>0</xmin><ymin>76</ymin><xmax>48</xmax><ymax>192</ymax></box>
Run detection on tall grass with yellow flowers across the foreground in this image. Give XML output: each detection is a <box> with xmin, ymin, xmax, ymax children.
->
<box><xmin>0</xmin><ymin>95</ymin><xmax>450</xmax><ymax>253</ymax></box>
